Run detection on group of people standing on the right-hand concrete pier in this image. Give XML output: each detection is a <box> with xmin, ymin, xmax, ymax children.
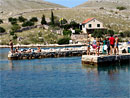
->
<box><xmin>87</xmin><ymin>35</ymin><xmax>119</xmax><ymax>56</ymax></box>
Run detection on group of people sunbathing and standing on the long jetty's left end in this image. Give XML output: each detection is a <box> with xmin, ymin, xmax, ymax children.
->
<box><xmin>9</xmin><ymin>40</ymin><xmax>41</xmax><ymax>53</ymax></box>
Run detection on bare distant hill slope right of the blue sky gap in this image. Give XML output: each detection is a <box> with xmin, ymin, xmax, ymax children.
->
<box><xmin>76</xmin><ymin>0</ymin><xmax>130</xmax><ymax>9</ymax></box>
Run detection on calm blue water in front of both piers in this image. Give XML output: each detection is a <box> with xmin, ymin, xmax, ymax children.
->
<box><xmin>0</xmin><ymin>48</ymin><xmax>130</xmax><ymax>98</ymax></box>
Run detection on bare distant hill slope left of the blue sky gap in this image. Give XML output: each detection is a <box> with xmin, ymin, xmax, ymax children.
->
<box><xmin>0</xmin><ymin>0</ymin><xmax>64</xmax><ymax>12</ymax></box>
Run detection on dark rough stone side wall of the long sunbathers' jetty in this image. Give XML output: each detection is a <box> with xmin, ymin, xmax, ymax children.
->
<box><xmin>8</xmin><ymin>50</ymin><xmax>86</xmax><ymax>60</ymax></box>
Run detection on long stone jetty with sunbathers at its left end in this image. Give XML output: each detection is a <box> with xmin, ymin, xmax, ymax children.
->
<box><xmin>8</xmin><ymin>47</ymin><xmax>87</xmax><ymax>60</ymax></box>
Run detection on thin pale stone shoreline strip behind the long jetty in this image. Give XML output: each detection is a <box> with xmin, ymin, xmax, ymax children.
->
<box><xmin>0</xmin><ymin>44</ymin><xmax>85</xmax><ymax>48</ymax></box>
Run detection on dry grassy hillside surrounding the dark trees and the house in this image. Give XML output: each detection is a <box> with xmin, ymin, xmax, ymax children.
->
<box><xmin>0</xmin><ymin>0</ymin><xmax>130</xmax><ymax>44</ymax></box>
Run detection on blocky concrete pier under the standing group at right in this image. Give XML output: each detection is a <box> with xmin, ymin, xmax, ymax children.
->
<box><xmin>82</xmin><ymin>53</ymin><xmax>130</xmax><ymax>65</ymax></box>
